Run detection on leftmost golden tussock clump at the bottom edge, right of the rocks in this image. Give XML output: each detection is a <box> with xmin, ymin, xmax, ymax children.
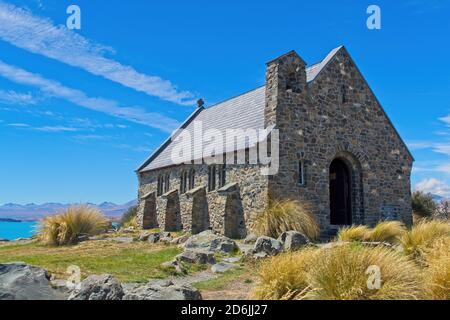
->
<box><xmin>251</xmin><ymin>248</ymin><xmax>318</xmax><ymax>300</ymax></box>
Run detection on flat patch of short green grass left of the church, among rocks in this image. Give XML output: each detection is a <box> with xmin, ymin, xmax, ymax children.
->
<box><xmin>0</xmin><ymin>240</ymin><xmax>181</xmax><ymax>282</ymax></box>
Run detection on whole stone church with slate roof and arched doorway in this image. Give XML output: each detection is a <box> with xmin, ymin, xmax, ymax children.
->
<box><xmin>137</xmin><ymin>47</ymin><xmax>414</xmax><ymax>238</ymax></box>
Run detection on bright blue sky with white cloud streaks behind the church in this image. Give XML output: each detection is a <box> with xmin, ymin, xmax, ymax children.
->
<box><xmin>0</xmin><ymin>0</ymin><xmax>450</xmax><ymax>204</ymax></box>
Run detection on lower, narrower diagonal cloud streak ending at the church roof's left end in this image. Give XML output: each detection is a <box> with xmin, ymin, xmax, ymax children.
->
<box><xmin>0</xmin><ymin>60</ymin><xmax>179</xmax><ymax>132</ymax></box>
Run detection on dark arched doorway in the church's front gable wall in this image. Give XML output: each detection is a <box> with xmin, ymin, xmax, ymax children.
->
<box><xmin>330</xmin><ymin>159</ymin><xmax>352</xmax><ymax>225</ymax></box>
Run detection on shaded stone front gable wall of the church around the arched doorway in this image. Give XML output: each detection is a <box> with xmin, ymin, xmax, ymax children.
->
<box><xmin>266</xmin><ymin>48</ymin><xmax>413</xmax><ymax>230</ymax></box>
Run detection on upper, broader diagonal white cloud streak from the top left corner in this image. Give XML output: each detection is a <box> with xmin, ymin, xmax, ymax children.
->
<box><xmin>0</xmin><ymin>1</ymin><xmax>194</xmax><ymax>105</ymax></box>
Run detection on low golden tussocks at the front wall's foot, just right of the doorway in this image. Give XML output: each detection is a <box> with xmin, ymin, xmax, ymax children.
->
<box><xmin>337</xmin><ymin>221</ymin><xmax>406</xmax><ymax>244</ymax></box>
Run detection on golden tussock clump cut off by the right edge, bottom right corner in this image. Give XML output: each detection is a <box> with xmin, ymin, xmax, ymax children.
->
<box><xmin>424</xmin><ymin>237</ymin><xmax>450</xmax><ymax>300</ymax></box>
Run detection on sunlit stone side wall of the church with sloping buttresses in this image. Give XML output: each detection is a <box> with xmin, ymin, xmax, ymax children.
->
<box><xmin>138</xmin><ymin>165</ymin><xmax>268</xmax><ymax>238</ymax></box>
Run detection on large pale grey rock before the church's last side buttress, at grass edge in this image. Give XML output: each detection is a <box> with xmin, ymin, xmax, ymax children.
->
<box><xmin>184</xmin><ymin>230</ymin><xmax>238</xmax><ymax>253</ymax></box>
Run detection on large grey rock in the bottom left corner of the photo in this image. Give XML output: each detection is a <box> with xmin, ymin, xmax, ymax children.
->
<box><xmin>0</xmin><ymin>263</ymin><xmax>67</xmax><ymax>300</ymax></box>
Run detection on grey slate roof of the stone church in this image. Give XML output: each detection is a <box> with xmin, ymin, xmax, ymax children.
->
<box><xmin>138</xmin><ymin>47</ymin><xmax>341</xmax><ymax>172</ymax></box>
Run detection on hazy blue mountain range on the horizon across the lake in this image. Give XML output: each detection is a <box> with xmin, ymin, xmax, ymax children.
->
<box><xmin>0</xmin><ymin>200</ymin><xmax>137</xmax><ymax>221</ymax></box>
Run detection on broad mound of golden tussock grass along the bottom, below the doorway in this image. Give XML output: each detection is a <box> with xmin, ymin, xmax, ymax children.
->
<box><xmin>252</xmin><ymin>244</ymin><xmax>424</xmax><ymax>300</ymax></box>
